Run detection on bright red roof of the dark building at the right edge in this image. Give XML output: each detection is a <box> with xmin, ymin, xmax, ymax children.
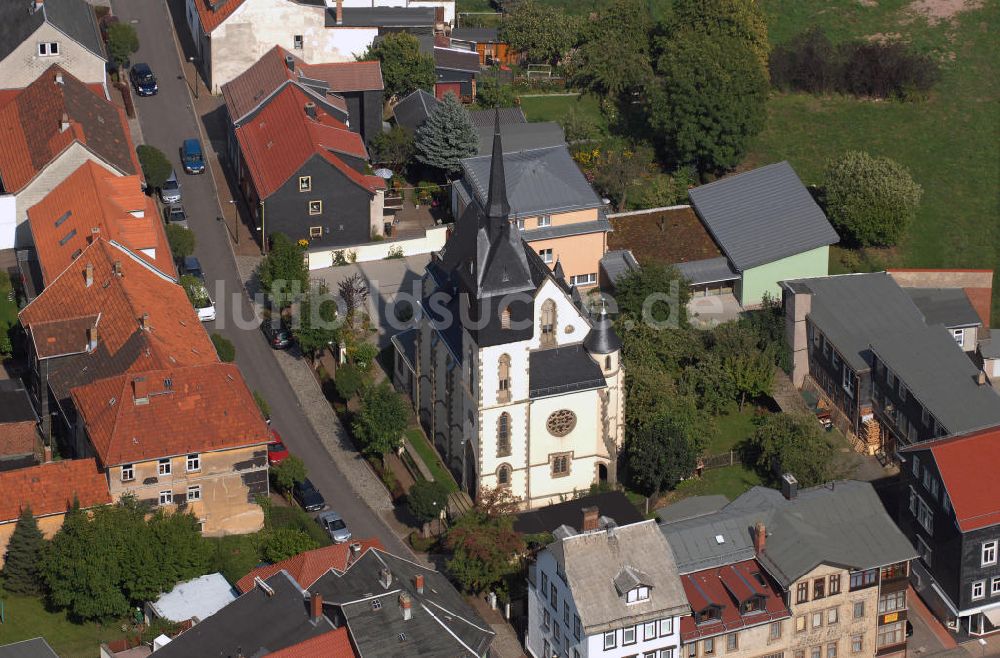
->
<box><xmin>903</xmin><ymin>427</ymin><xmax>1000</xmax><ymax>532</ymax></box>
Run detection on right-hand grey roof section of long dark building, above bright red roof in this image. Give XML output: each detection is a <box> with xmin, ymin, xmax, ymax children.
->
<box><xmin>872</xmin><ymin>325</ymin><xmax>1000</xmax><ymax>434</ymax></box>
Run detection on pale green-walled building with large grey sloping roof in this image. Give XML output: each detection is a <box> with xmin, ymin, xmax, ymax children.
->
<box><xmin>689</xmin><ymin>162</ymin><xmax>839</xmax><ymax>308</ymax></box>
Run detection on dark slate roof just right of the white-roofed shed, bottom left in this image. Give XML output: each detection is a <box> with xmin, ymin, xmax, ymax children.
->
<box><xmin>149</xmin><ymin>572</ymin><xmax>334</xmax><ymax>658</ymax></box>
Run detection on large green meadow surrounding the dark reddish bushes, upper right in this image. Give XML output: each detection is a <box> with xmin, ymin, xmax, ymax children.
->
<box><xmin>746</xmin><ymin>0</ymin><xmax>1000</xmax><ymax>323</ymax></box>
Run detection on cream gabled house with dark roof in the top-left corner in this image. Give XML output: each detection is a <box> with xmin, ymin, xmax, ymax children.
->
<box><xmin>0</xmin><ymin>0</ymin><xmax>107</xmax><ymax>91</ymax></box>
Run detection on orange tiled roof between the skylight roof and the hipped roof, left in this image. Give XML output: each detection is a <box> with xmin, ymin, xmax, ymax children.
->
<box><xmin>19</xmin><ymin>238</ymin><xmax>218</xmax><ymax>372</ymax></box>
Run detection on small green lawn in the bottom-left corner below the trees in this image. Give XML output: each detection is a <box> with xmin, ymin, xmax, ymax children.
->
<box><xmin>0</xmin><ymin>594</ymin><xmax>124</xmax><ymax>658</ymax></box>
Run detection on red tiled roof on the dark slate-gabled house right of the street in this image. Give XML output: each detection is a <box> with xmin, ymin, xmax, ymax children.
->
<box><xmin>236</xmin><ymin>87</ymin><xmax>385</xmax><ymax>198</ymax></box>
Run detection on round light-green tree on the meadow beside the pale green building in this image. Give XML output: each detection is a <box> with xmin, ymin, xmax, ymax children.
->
<box><xmin>825</xmin><ymin>151</ymin><xmax>923</xmax><ymax>247</ymax></box>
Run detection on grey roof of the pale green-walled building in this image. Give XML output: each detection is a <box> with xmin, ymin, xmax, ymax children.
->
<box><xmin>688</xmin><ymin>162</ymin><xmax>840</xmax><ymax>272</ymax></box>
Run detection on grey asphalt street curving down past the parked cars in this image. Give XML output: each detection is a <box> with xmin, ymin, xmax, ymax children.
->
<box><xmin>112</xmin><ymin>0</ymin><xmax>409</xmax><ymax>555</ymax></box>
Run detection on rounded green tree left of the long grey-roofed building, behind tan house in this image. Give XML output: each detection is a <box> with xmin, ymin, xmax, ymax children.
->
<box><xmin>746</xmin><ymin>413</ymin><xmax>837</xmax><ymax>487</ymax></box>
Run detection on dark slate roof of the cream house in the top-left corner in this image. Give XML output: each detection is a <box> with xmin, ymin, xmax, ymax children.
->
<box><xmin>0</xmin><ymin>0</ymin><xmax>104</xmax><ymax>62</ymax></box>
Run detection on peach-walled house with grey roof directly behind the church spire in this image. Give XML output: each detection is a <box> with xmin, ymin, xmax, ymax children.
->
<box><xmin>452</xmin><ymin>145</ymin><xmax>611</xmax><ymax>288</ymax></box>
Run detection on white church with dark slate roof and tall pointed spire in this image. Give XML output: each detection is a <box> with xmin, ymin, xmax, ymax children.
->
<box><xmin>394</xmin><ymin>119</ymin><xmax>624</xmax><ymax>508</ymax></box>
